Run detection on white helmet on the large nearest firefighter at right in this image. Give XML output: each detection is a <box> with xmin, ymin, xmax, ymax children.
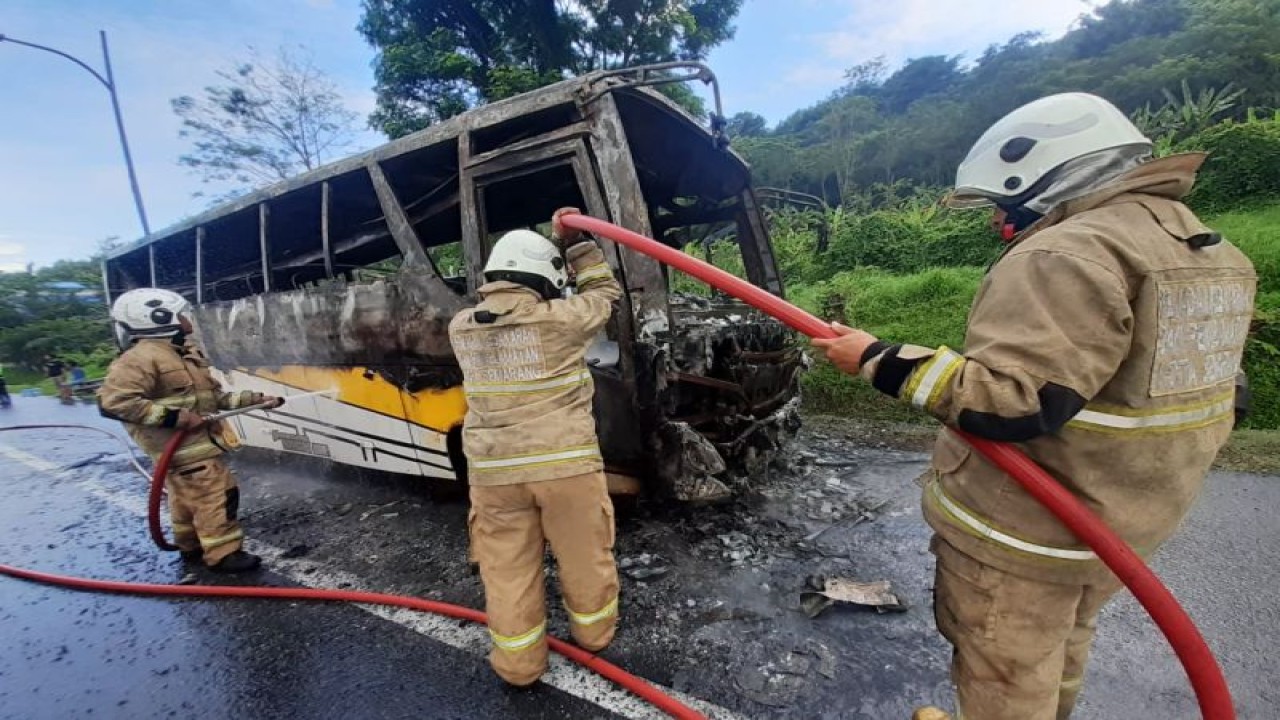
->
<box><xmin>947</xmin><ymin>92</ymin><xmax>1152</xmax><ymax>208</ymax></box>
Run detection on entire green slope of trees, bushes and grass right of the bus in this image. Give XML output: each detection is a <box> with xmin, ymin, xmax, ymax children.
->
<box><xmin>711</xmin><ymin>0</ymin><xmax>1280</xmax><ymax>428</ymax></box>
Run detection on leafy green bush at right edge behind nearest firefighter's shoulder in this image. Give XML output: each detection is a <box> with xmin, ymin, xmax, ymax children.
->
<box><xmin>1178</xmin><ymin>117</ymin><xmax>1280</xmax><ymax>213</ymax></box>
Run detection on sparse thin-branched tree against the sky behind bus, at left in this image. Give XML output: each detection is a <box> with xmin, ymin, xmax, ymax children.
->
<box><xmin>170</xmin><ymin>49</ymin><xmax>357</xmax><ymax>193</ymax></box>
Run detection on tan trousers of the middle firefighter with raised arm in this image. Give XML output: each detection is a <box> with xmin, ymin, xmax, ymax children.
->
<box><xmin>468</xmin><ymin>473</ymin><xmax>618</xmax><ymax>685</ymax></box>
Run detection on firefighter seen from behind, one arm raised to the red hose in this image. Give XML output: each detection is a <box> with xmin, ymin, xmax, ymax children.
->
<box><xmin>449</xmin><ymin>208</ymin><xmax>622</xmax><ymax>687</ymax></box>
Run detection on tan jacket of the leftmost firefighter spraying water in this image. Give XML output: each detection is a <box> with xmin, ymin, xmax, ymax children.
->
<box><xmin>97</xmin><ymin>338</ymin><xmax>257</xmax><ymax>468</ymax></box>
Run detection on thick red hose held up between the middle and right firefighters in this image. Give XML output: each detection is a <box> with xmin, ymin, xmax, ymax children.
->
<box><xmin>559</xmin><ymin>215</ymin><xmax>1235</xmax><ymax>720</ymax></box>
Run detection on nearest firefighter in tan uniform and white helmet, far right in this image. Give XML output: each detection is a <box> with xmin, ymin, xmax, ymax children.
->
<box><xmin>815</xmin><ymin>94</ymin><xmax>1256</xmax><ymax>720</ymax></box>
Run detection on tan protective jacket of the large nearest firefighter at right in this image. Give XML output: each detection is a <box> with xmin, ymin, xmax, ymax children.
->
<box><xmin>861</xmin><ymin>155</ymin><xmax>1256</xmax><ymax>584</ymax></box>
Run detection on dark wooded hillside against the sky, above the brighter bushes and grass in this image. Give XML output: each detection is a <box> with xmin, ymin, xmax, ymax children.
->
<box><xmin>728</xmin><ymin>0</ymin><xmax>1280</xmax><ymax>204</ymax></box>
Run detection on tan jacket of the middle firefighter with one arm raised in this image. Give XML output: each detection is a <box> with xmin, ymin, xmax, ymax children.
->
<box><xmin>449</xmin><ymin>242</ymin><xmax>622</xmax><ymax>486</ymax></box>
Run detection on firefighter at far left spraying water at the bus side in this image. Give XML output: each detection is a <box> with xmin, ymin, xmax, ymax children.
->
<box><xmin>99</xmin><ymin>288</ymin><xmax>283</xmax><ymax>573</ymax></box>
